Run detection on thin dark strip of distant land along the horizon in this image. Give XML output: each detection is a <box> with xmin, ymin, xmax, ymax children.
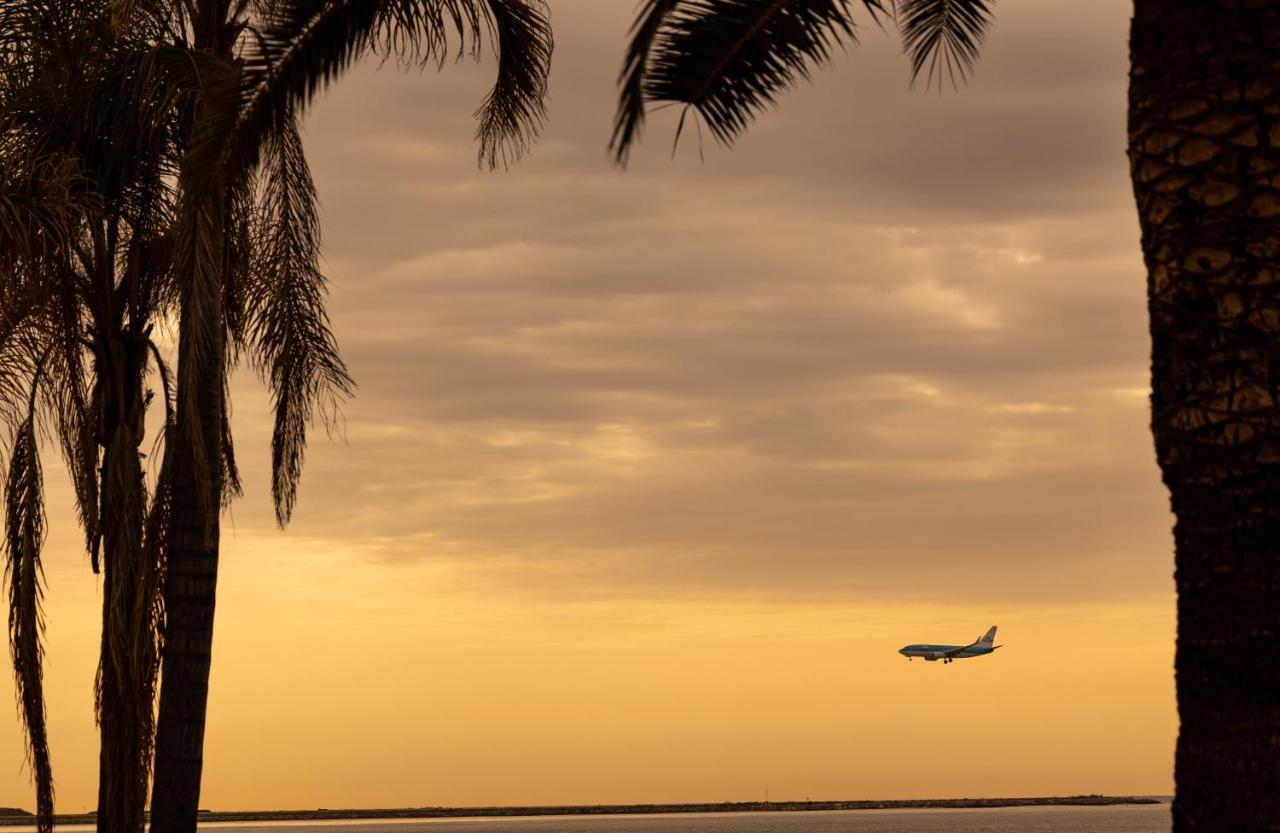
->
<box><xmin>0</xmin><ymin>795</ymin><xmax>1164</xmax><ymax>827</ymax></box>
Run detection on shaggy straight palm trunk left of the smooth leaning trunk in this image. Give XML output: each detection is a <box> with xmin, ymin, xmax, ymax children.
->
<box><xmin>97</xmin><ymin>337</ymin><xmax>156</xmax><ymax>833</ymax></box>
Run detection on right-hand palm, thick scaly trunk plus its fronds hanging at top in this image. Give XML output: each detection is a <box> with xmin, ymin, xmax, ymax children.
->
<box><xmin>612</xmin><ymin>0</ymin><xmax>1280</xmax><ymax>833</ymax></box>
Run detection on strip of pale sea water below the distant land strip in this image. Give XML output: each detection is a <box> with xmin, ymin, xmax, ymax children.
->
<box><xmin>9</xmin><ymin>804</ymin><xmax>1172</xmax><ymax>833</ymax></box>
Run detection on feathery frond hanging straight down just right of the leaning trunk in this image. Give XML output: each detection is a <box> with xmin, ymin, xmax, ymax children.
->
<box><xmin>247</xmin><ymin>113</ymin><xmax>352</xmax><ymax>526</ymax></box>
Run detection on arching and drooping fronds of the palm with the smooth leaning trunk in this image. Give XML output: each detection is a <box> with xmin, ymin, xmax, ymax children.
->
<box><xmin>157</xmin><ymin>0</ymin><xmax>552</xmax><ymax>526</ymax></box>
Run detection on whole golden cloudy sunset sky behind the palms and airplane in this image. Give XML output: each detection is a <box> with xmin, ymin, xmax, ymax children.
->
<box><xmin>0</xmin><ymin>0</ymin><xmax>1176</xmax><ymax>811</ymax></box>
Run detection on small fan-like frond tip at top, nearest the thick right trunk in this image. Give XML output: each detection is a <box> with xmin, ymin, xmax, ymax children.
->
<box><xmin>897</xmin><ymin>0</ymin><xmax>995</xmax><ymax>87</ymax></box>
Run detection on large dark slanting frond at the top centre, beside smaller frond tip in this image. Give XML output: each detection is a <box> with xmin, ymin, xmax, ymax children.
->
<box><xmin>613</xmin><ymin>0</ymin><xmax>884</xmax><ymax>161</ymax></box>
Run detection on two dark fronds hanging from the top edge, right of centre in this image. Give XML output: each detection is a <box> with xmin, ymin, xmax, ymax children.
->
<box><xmin>609</xmin><ymin>0</ymin><xmax>993</xmax><ymax>164</ymax></box>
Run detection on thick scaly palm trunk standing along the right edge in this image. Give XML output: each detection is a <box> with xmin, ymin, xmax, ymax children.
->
<box><xmin>1129</xmin><ymin>0</ymin><xmax>1280</xmax><ymax>833</ymax></box>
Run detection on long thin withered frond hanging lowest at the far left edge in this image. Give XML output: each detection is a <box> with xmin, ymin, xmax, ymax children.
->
<box><xmin>5</xmin><ymin>401</ymin><xmax>54</xmax><ymax>833</ymax></box>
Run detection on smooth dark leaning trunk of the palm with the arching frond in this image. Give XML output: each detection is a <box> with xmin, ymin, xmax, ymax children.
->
<box><xmin>151</xmin><ymin>64</ymin><xmax>238</xmax><ymax>833</ymax></box>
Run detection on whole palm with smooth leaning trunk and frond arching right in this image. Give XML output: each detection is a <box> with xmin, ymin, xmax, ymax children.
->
<box><xmin>151</xmin><ymin>0</ymin><xmax>552</xmax><ymax>833</ymax></box>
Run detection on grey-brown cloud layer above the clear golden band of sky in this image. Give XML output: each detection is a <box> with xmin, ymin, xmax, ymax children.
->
<box><xmin>220</xmin><ymin>0</ymin><xmax>1169</xmax><ymax>600</ymax></box>
